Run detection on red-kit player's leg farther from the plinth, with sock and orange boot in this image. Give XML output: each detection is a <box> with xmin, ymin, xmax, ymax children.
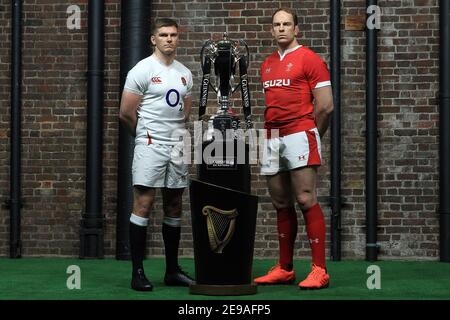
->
<box><xmin>291</xmin><ymin>167</ymin><xmax>329</xmax><ymax>289</ymax></box>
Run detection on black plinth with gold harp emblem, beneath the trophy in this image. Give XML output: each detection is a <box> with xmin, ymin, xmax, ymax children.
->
<box><xmin>190</xmin><ymin>179</ymin><xmax>258</xmax><ymax>295</ymax></box>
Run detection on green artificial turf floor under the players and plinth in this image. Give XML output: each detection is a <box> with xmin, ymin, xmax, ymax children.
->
<box><xmin>0</xmin><ymin>257</ymin><xmax>450</xmax><ymax>300</ymax></box>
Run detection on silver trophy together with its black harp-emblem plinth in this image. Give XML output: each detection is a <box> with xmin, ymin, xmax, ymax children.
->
<box><xmin>189</xmin><ymin>33</ymin><xmax>258</xmax><ymax>295</ymax></box>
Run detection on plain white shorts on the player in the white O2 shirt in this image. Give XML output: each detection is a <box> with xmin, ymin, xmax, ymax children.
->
<box><xmin>132</xmin><ymin>144</ymin><xmax>188</xmax><ymax>189</ymax></box>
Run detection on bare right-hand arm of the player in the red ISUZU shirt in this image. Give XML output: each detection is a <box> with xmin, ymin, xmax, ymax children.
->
<box><xmin>312</xmin><ymin>86</ymin><xmax>333</xmax><ymax>138</ymax></box>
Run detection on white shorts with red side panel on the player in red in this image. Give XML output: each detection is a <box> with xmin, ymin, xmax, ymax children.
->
<box><xmin>261</xmin><ymin>128</ymin><xmax>321</xmax><ymax>175</ymax></box>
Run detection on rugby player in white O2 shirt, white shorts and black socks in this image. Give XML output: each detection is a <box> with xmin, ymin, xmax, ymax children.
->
<box><xmin>120</xmin><ymin>18</ymin><xmax>193</xmax><ymax>291</ymax></box>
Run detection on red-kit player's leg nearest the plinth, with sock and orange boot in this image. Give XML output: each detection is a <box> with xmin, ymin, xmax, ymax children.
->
<box><xmin>255</xmin><ymin>172</ymin><xmax>297</xmax><ymax>284</ymax></box>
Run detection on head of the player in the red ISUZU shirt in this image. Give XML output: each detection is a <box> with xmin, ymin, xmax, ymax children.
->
<box><xmin>272</xmin><ymin>11</ymin><xmax>299</xmax><ymax>48</ymax></box>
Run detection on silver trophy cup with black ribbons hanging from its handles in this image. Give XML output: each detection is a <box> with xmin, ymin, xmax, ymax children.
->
<box><xmin>199</xmin><ymin>32</ymin><xmax>252</xmax><ymax>140</ymax></box>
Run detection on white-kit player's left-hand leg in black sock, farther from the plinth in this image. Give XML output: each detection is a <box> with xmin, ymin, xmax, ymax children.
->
<box><xmin>130</xmin><ymin>185</ymin><xmax>155</xmax><ymax>291</ymax></box>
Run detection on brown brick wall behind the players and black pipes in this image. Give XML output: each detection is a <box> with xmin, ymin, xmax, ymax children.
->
<box><xmin>0</xmin><ymin>0</ymin><xmax>439</xmax><ymax>259</ymax></box>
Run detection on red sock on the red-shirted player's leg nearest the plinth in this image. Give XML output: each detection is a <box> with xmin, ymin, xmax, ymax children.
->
<box><xmin>277</xmin><ymin>207</ymin><xmax>297</xmax><ymax>271</ymax></box>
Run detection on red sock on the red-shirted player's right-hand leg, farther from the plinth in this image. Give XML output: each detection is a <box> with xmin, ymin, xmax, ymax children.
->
<box><xmin>303</xmin><ymin>203</ymin><xmax>326</xmax><ymax>269</ymax></box>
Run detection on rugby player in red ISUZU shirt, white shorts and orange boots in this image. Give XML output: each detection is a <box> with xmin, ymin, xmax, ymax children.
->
<box><xmin>254</xmin><ymin>9</ymin><xmax>333</xmax><ymax>289</ymax></box>
